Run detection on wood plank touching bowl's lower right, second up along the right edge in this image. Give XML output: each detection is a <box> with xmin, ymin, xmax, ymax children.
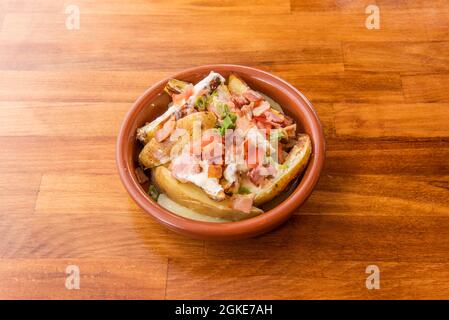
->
<box><xmin>205</xmin><ymin>215</ymin><xmax>449</xmax><ymax>262</ymax></box>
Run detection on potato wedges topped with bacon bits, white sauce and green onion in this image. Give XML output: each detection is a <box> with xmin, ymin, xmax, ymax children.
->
<box><xmin>136</xmin><ymin>71</ymin><xmax>312</xmax><ymax>222</ymax></box>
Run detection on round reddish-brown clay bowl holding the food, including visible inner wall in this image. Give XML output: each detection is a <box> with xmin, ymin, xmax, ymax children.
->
<box><xmin>116</xmin><ymin>65</ymin><xmax>325</xmax><ymax>240</ymax></box>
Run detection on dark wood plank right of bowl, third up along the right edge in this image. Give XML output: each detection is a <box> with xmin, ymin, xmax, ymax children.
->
<box><xmin>299</xmin><ymin>172</ymin><xmax>449</xmax><ymax>219</ymax></box>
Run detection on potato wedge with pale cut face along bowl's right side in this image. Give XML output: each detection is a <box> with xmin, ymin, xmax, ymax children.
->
<box><xmin>254</xmin><ymin>134</ymin><xmax>312</xmax><ymax>206</ymax></box>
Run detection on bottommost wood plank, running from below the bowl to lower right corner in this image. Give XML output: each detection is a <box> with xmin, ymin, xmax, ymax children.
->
<box><xmin>167</xmin><ymin>258</ymin><xmax>448</xmax><ymax>299</ymax></box>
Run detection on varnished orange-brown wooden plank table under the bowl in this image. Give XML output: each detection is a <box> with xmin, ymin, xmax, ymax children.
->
<box><xmin>0</xmin><ymin>0</ymin><xmax>449</xmax><ymax>299</ymax></box>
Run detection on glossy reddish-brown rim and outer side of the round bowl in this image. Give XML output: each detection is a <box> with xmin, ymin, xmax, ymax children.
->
<box><xmin>116</xmin><ymin>64</ymin><xmax>325</xmax><ymax>240</ymax></box>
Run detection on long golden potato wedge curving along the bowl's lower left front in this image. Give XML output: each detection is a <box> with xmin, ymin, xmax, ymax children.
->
<box><xmin>152</xmin><ymin>166</ymin><xmax>263</xmax><ymax>221</ymax></box>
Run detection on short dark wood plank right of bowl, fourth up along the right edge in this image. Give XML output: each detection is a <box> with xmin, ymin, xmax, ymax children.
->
<box><xmin>325</xmin><ymin>138</ymin><xmax>449</xmax><ymax>175</ymax></box>
